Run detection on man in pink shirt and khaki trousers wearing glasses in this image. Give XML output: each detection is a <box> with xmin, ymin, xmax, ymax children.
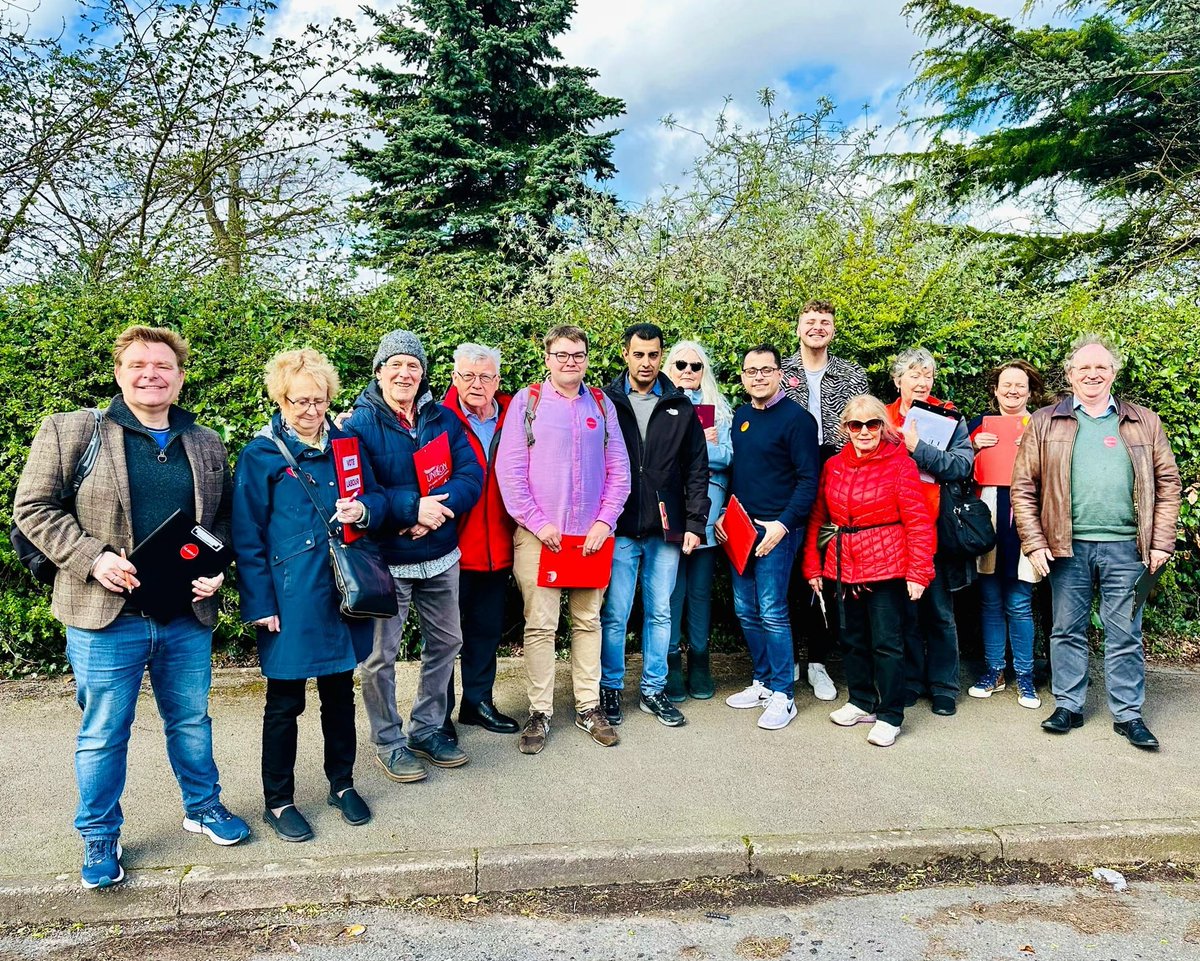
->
<box><xmin>496</xmin><ymin>325</ymin><xmax>630</xmax><ymax>755</ymax></box>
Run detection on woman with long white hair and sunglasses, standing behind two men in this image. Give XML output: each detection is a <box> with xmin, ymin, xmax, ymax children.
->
<box><xmin>664</xmin><ymin>341</ymin><xmax>733</xmax><ymax>702</ymax></box>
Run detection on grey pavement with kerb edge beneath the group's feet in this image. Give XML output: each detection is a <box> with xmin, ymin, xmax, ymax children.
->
<box><xmin>0</xmin><ymin>657</ymin><xmax>1200</xmax><ymax>919</ymax></box>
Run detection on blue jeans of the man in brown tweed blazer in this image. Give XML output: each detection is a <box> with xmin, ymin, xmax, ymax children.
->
<box><xmin>67</xmin><ymin>614</ymin><xmax>221</xmax><ymax>839</ymax></box>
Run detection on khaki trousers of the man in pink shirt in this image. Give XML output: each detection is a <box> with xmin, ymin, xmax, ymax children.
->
<box><xmin>512</xmin><ymin>527</ymin><xmax>604</xmax><ymax>717</ymax></box>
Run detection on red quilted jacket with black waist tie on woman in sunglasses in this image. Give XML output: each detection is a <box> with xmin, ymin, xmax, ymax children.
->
<box><xmin>803</xmin><ymin>440</ymin><xmax>934</xmax><ymax>587</ymax></box>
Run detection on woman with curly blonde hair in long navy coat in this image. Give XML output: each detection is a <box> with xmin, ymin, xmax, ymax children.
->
<box><xmin>233</xmin><ymin>349</ymin><xmax>388</xmax><ymax>841</ymax></box>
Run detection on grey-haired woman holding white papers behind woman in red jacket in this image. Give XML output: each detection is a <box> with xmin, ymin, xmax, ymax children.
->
<box><xmin>888</xmin><ymin>347</ymin><xmax>974</xmax><ymax>716</ymax></box>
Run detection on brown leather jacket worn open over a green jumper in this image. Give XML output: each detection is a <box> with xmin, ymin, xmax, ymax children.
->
<box><xmin>1010</xmin><ymin>395</ymin><xmax>1182</xmax><ymax>565</ymax></box>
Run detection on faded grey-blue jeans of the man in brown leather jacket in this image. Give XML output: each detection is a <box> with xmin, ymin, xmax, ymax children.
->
<box><xmin>1050</xmin><ymin>541</ymin><xmax>1146</xmax><ymax>721</ymax></box>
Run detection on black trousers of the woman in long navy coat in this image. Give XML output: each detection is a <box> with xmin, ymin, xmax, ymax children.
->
<box><xmin>263</xmin><ymin>671</ymin><xmax>358</xmax><ymax>807</ymax></box>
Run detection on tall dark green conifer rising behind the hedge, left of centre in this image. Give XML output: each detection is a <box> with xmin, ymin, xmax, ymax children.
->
<box><xmin>347</xmin><ymin>0</ymin><xmax>625</xmax><ymax>264</ymax></box>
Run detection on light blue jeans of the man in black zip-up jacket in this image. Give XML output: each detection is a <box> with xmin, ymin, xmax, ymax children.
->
<box><xmin>600</xmin><ymin>536</ymin><xmax>683</xmax><ymax>695</ymax></box>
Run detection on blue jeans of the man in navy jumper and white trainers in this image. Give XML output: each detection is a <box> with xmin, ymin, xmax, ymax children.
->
<box><xmin>731</xmin><ymin>530</ymin><xmax>803</xmax><ymax>697</ymax></box>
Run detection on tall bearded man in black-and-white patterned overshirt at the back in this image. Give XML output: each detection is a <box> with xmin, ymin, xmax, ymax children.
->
<box><xmin>782</xmin><ymin>300</ymin><xmax>870</xmax><ymax>701</ymax></box>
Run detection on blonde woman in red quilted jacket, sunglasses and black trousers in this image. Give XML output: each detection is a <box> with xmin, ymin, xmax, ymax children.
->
<box><xmin>803</xmin><ymin>394</ymin><xmax>935</xmax><ymax>747</ymax></box>
